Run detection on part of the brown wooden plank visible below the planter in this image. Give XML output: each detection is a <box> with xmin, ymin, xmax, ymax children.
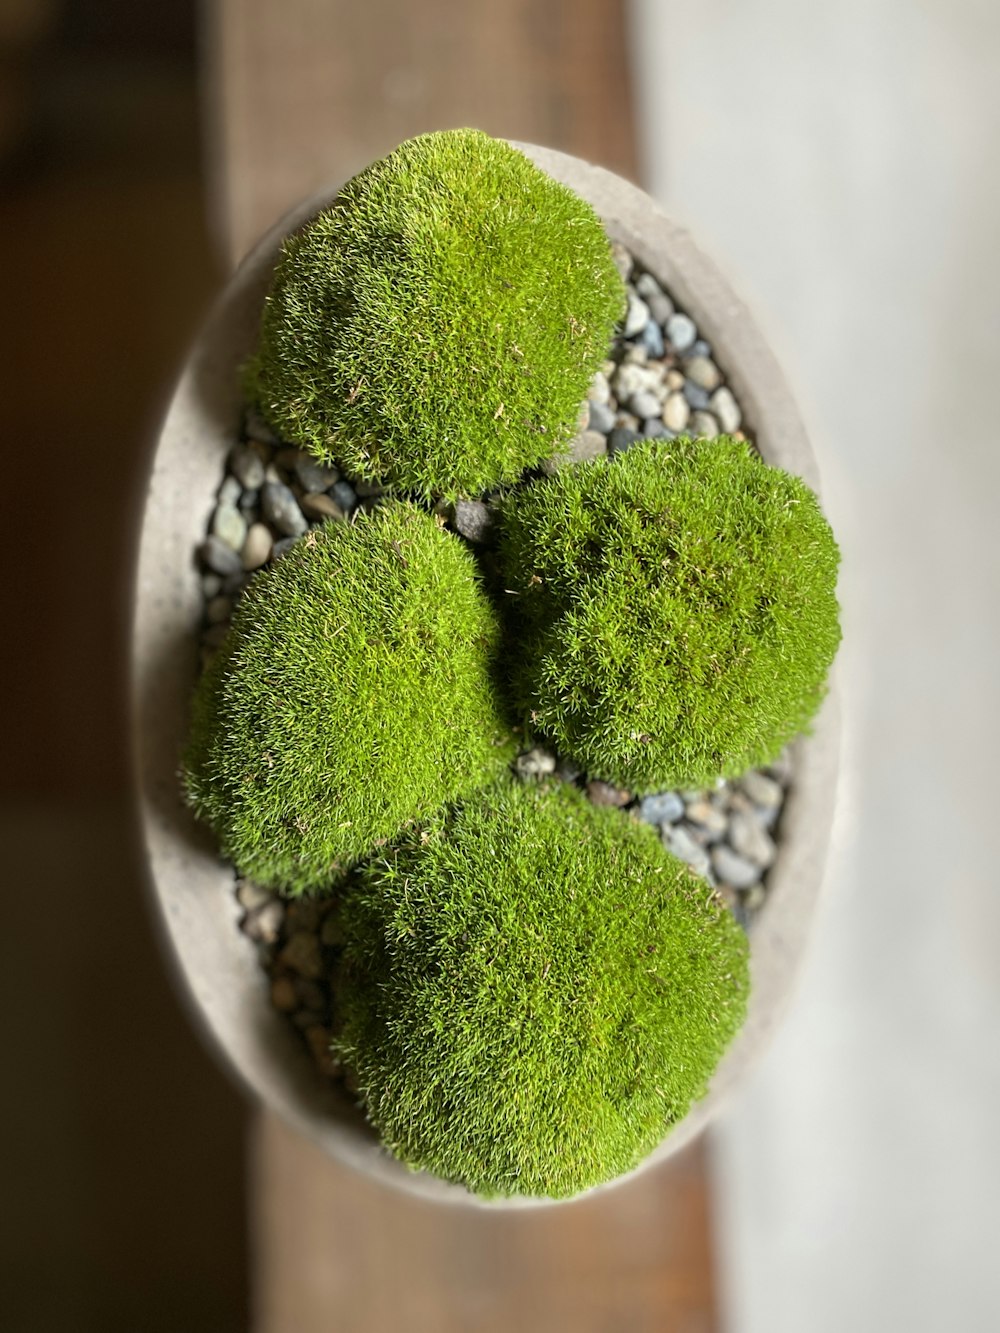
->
<box><xmin>251</xmin><ymin>1116</ymin><xmax>716</xmax><ymax>1333</ymax></box>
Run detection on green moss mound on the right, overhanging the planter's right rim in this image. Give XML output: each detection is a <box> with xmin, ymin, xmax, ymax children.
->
<box><xmin>501</xmin><ymin>436</ymin><xmax>840</xmax><ymax>790</ymax></box>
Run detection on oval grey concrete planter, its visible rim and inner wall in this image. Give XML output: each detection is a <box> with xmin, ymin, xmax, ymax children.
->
<box><xmin>132</xmin><ymin>144</ymin><xmax>839</xmax><ymax>1206</ymax></box>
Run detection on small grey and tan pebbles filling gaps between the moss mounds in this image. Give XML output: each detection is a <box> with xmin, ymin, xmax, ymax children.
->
<box><xmin>197</xmin><ymin>243</ymin><xmax>792</xmax><ymax>1085</ymax></box>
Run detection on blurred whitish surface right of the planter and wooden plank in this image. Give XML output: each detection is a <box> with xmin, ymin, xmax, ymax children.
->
<box><xmin>632</xmin><ymin>0</ymin><xmax>1000</xmax><ymax>1333</ymax></box>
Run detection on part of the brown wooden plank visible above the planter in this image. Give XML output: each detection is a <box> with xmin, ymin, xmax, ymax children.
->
<box><xmin>207</xmin><ymin>0</ymin><xmax>636</xmax><ymax>259</ymax></box>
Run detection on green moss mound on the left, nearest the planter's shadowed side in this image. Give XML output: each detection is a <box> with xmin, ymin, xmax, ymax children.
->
<box><xmin>185</xmin><ymin>503</ymin><xmax>505</xmax><ymax>893</ymax></box>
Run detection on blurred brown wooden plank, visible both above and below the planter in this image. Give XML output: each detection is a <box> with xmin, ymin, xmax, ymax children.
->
<box><xmin>208</xmin><ymin>0</ymin><xmax>717</xmax><ymax>1333</ymax></box>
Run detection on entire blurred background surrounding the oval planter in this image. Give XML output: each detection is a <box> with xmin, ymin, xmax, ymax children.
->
<box><xmin>0</xmin><ymin>0</ymin><xmax>1000</xmax><ymax>1333</ymax></box>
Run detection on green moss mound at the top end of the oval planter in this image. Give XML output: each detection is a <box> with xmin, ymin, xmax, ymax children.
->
<box><xmin>247</xmin><ymin>129</ymin><xmax>624</xmax><ymax>497</ymax></box>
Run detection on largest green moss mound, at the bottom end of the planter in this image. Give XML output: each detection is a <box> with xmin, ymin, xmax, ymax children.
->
<box><xmin>336</xmin><ymin>785</ymin><xmax>748</xmax><ymax>1197</ymax></box>
